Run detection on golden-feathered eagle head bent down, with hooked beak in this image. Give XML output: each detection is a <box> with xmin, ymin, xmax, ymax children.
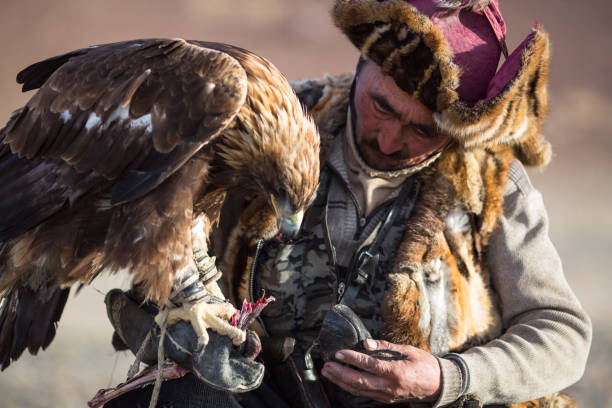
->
<box><xmin>215</xmin><ymin>66</ymin><xmax>320</xmax><ymax>238</ymax></box>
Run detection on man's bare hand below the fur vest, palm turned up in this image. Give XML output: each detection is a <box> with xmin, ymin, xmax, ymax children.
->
<box><xmin>321</xmin><ymin>339</ymin><xmax>442</xmax><ymax>404</ymax></box>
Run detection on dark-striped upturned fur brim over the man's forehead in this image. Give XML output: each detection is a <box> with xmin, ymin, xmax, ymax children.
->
<box><xmin>332</xmin><ymin>0</ymin><xmax>460</xmax><ymax>112</ymax></box>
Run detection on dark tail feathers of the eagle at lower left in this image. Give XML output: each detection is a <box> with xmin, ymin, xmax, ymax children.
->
<box><xmin>0</xmin><ymin>285</ymin><xmax>70</xmax><ymax>370</ymax></box>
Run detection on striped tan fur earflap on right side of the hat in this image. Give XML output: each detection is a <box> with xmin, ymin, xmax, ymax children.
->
<box><xmin>434</xmin><ymin>29</ymin><xmax>551</xmax><ymax>166</ymax></box>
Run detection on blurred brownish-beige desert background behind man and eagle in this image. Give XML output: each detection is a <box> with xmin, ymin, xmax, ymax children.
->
<box><xmin>0</xmin><ymin>0</ymin><xmax>612</xmax><ymax>408</ymax></box>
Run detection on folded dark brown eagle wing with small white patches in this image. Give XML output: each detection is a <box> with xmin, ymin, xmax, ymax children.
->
<box><xmin>0</xmin><ymin>39</ymin><xmax>247</xmax><ymax>242</ymax></box>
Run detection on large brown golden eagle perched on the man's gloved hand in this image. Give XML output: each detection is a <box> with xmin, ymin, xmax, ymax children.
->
<box><xmin>0</xmin><ymin>39</ymin><xmax>319</xmax><ymax>369</ymax></box>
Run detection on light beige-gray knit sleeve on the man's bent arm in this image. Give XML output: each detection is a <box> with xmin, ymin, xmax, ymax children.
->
<box><xmin>436</xmin><ymin>161</ymin><xmax>591</xmax><ymax>406</ymax></box>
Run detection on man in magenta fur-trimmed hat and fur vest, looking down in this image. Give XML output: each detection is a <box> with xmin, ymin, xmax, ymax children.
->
<box><xmin>105</xmin><ymin>0</ymin><xmax>591</xmax><ymax>407</ymax></box>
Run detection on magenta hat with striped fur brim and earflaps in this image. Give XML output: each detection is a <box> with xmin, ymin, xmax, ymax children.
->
<box><xmin>332</xmin><ymin>0</ymin><xmax>551</xmax><ymax>165</ymax></box>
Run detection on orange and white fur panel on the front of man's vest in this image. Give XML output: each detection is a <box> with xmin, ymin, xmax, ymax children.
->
<box><xmin>383</xmin><ymin>146</ymin><xmax>514</xmax><ymax>353</ymax></box>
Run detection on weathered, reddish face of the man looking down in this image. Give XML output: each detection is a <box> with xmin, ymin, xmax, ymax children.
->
<box><xmin>354</xmin><ymin>61</ymin><xmax>450</xmax><ymax>170</ymax></box>
